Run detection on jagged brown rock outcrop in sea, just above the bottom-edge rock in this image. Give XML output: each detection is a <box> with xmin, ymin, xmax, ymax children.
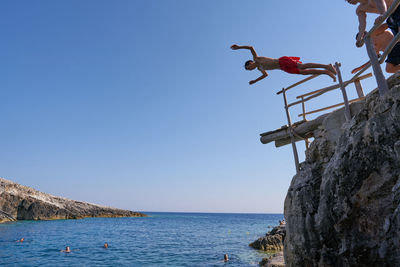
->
<box><xmin>249</xmin><ymin>225</ymin><xmax>286</xmax><ymax>252</ymax></box>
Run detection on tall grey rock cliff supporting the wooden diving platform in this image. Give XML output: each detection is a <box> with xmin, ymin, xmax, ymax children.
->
<box><xmin>284</xmin><ymin>76</ymin><xmax>400</xmax><ymax>266</ymax></box>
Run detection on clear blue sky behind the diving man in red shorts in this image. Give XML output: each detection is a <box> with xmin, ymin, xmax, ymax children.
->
<box><xmin>0</xmin><ymin>0</ymin><xmax>388</xmax><ymax>213</ymax></box>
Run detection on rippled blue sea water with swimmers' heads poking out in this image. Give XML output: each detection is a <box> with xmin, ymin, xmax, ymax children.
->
<box><xmin>0</xmin><ymin>213</ymin><xmax>283</xmax><ymax>266</ymax></box>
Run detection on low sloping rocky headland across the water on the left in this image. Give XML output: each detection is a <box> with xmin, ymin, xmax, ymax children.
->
<box><xmin>0</xmin><ymin>178</ymin><xmax>146</xmax><ymax>222</ymax></box>
